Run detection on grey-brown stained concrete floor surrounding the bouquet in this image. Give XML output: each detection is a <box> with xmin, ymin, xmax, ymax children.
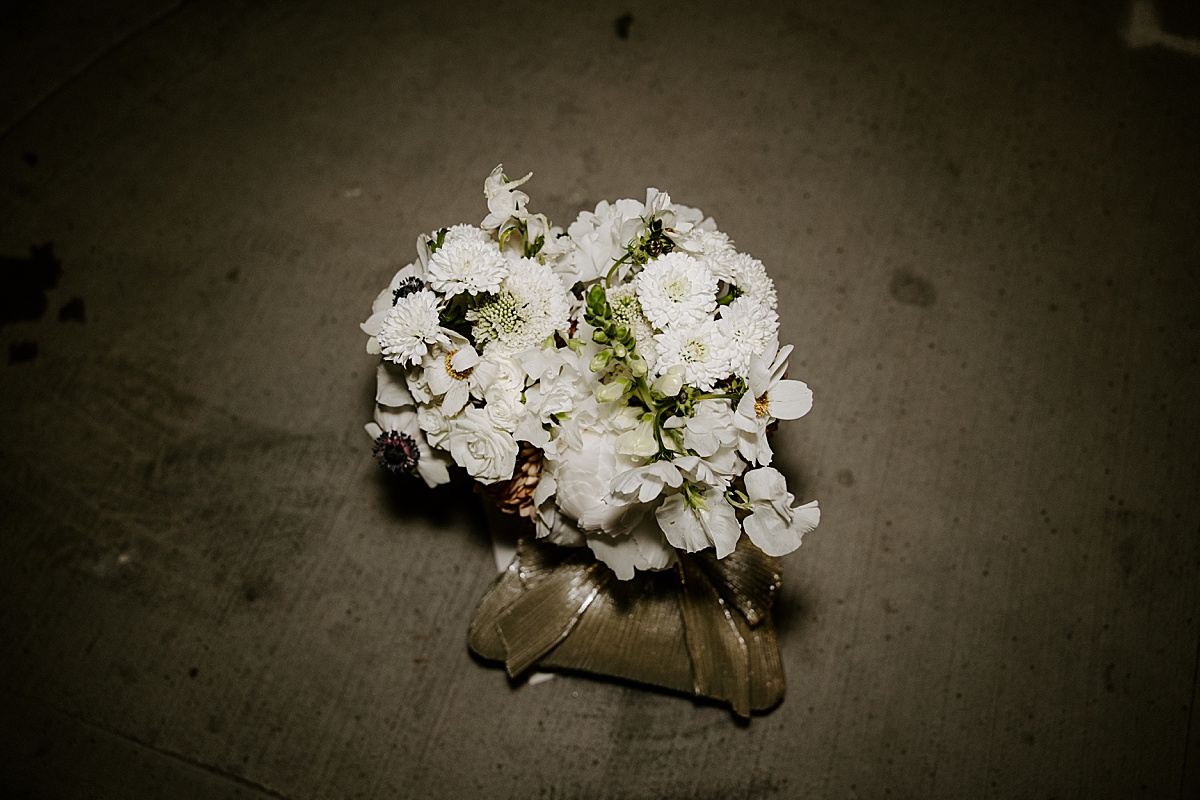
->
<box><xmin>0</xmin><ymin>0</ymin><xmax>1200</xmax><ymax>800</ymax></box>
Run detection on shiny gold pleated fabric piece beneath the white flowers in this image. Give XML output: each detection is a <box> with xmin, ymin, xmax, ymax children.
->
<box><xmin>469</xmin><ymin>536</ymin><xmax>785</xmax><ymax>717</ymax></box>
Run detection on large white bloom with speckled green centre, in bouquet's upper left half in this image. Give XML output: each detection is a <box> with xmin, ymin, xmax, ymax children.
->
<box><xmin>467</xmin><ymin>258</ymin><xmax>571</xmax><ymax>356</ymax></box>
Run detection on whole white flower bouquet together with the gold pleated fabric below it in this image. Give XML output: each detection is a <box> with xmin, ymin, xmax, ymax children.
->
<box><xmin>362</xmin><ymin>167</ymin><xmax>820</xmax><ymax>714</ymax></box>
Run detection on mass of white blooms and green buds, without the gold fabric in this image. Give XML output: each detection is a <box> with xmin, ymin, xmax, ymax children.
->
<box><xmin>361</xmin><ymin>167</ymin><xmax>820</xmax><ymax>581</ymax></box>
